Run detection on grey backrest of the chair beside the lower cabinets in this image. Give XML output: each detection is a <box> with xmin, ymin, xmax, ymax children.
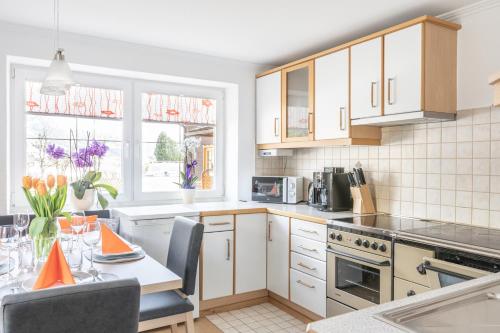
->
<box><xmin>167</xmin><ymin>216</ymin><xmax>204</xmax><ymax>295</ymax></box>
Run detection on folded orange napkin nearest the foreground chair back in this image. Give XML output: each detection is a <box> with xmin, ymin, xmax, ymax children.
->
<box><xmin>33</xmin><ymin>240</ymin><xmax>75</xmax><ymax>290</ymax></box>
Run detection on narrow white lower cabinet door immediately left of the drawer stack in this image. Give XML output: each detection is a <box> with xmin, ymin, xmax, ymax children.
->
<box><xmin>267</xmin><ymin>214</ymin><xmax>290</xmax><ymax>299</ymax></box>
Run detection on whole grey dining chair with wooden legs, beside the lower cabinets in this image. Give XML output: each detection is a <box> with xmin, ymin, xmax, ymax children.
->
<box><xmin>139</xmin><ymin>216</ymin><xmax>203</xmax><ymax>333</ymax></box>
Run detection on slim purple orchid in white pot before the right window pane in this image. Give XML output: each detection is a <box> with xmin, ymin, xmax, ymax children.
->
<box><xmin>176</xmin><ymin>137</ymin><xmax>200</xmax><ymax>204</ymax></box>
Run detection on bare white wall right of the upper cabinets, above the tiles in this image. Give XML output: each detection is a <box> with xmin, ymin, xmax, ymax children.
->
<box><xmin>440</xmin><ymin>0</ymin><xmax>500</xmax><ymax>110</ymax></box>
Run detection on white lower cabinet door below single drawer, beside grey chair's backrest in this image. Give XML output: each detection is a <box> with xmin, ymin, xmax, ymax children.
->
<box><xmin>202</xmin><ymin>231</ymin><xmax>233</xmax><ymax>300</ymax></box>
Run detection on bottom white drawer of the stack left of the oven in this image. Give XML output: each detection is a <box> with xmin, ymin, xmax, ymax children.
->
<box><xmin>290</xmin><ymin>269</ymin><xmax>326</xmax><ymax>318</ymax></box>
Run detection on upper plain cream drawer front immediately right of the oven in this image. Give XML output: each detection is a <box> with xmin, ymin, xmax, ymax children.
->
<box><xmin>394</xmin><ymin>243</ymin><xmax>434</xmax><ymax>287</ymax></box>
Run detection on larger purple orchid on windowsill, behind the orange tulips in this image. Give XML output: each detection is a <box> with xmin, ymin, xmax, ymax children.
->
<box><xmin>46</xmin><ymin>131</ymin><xmax>118</xmax><ymax>209</ymax></box>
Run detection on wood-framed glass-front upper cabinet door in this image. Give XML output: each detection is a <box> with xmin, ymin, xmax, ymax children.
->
<box><xmin>281</xmin><ymin>61</ymin><xmax>314</xmax><ymax>142</ymax></box>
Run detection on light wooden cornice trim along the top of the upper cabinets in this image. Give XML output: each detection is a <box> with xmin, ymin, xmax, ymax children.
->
<box><xmin>256</xmin><ymin>15</ymin><xmax>462</xmax><ymax>77</ymax></box>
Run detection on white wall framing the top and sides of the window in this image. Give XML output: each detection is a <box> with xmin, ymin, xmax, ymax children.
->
<box><xmin>0</xmin><ymin>22</ymin><xmax>264</xmax><ymax>214</ymax></box>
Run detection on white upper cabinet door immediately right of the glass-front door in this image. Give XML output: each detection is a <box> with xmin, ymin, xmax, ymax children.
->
<box><xmin>314</xmin><ymin>49</ymin><xmax>350</xmax><ymax>140</ymax></box>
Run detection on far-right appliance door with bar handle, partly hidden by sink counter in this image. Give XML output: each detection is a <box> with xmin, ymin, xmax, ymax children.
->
<box><xmin>421</xmin><ymin>257</ymin><xmax>491</xmax><ymax>289</ymax></box>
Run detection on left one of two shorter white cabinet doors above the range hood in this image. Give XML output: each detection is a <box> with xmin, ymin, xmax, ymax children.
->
<box><xmin>351</xmin><ymin>37</ymin><xmax>382</xmax><ymax>119</ymax></box>
